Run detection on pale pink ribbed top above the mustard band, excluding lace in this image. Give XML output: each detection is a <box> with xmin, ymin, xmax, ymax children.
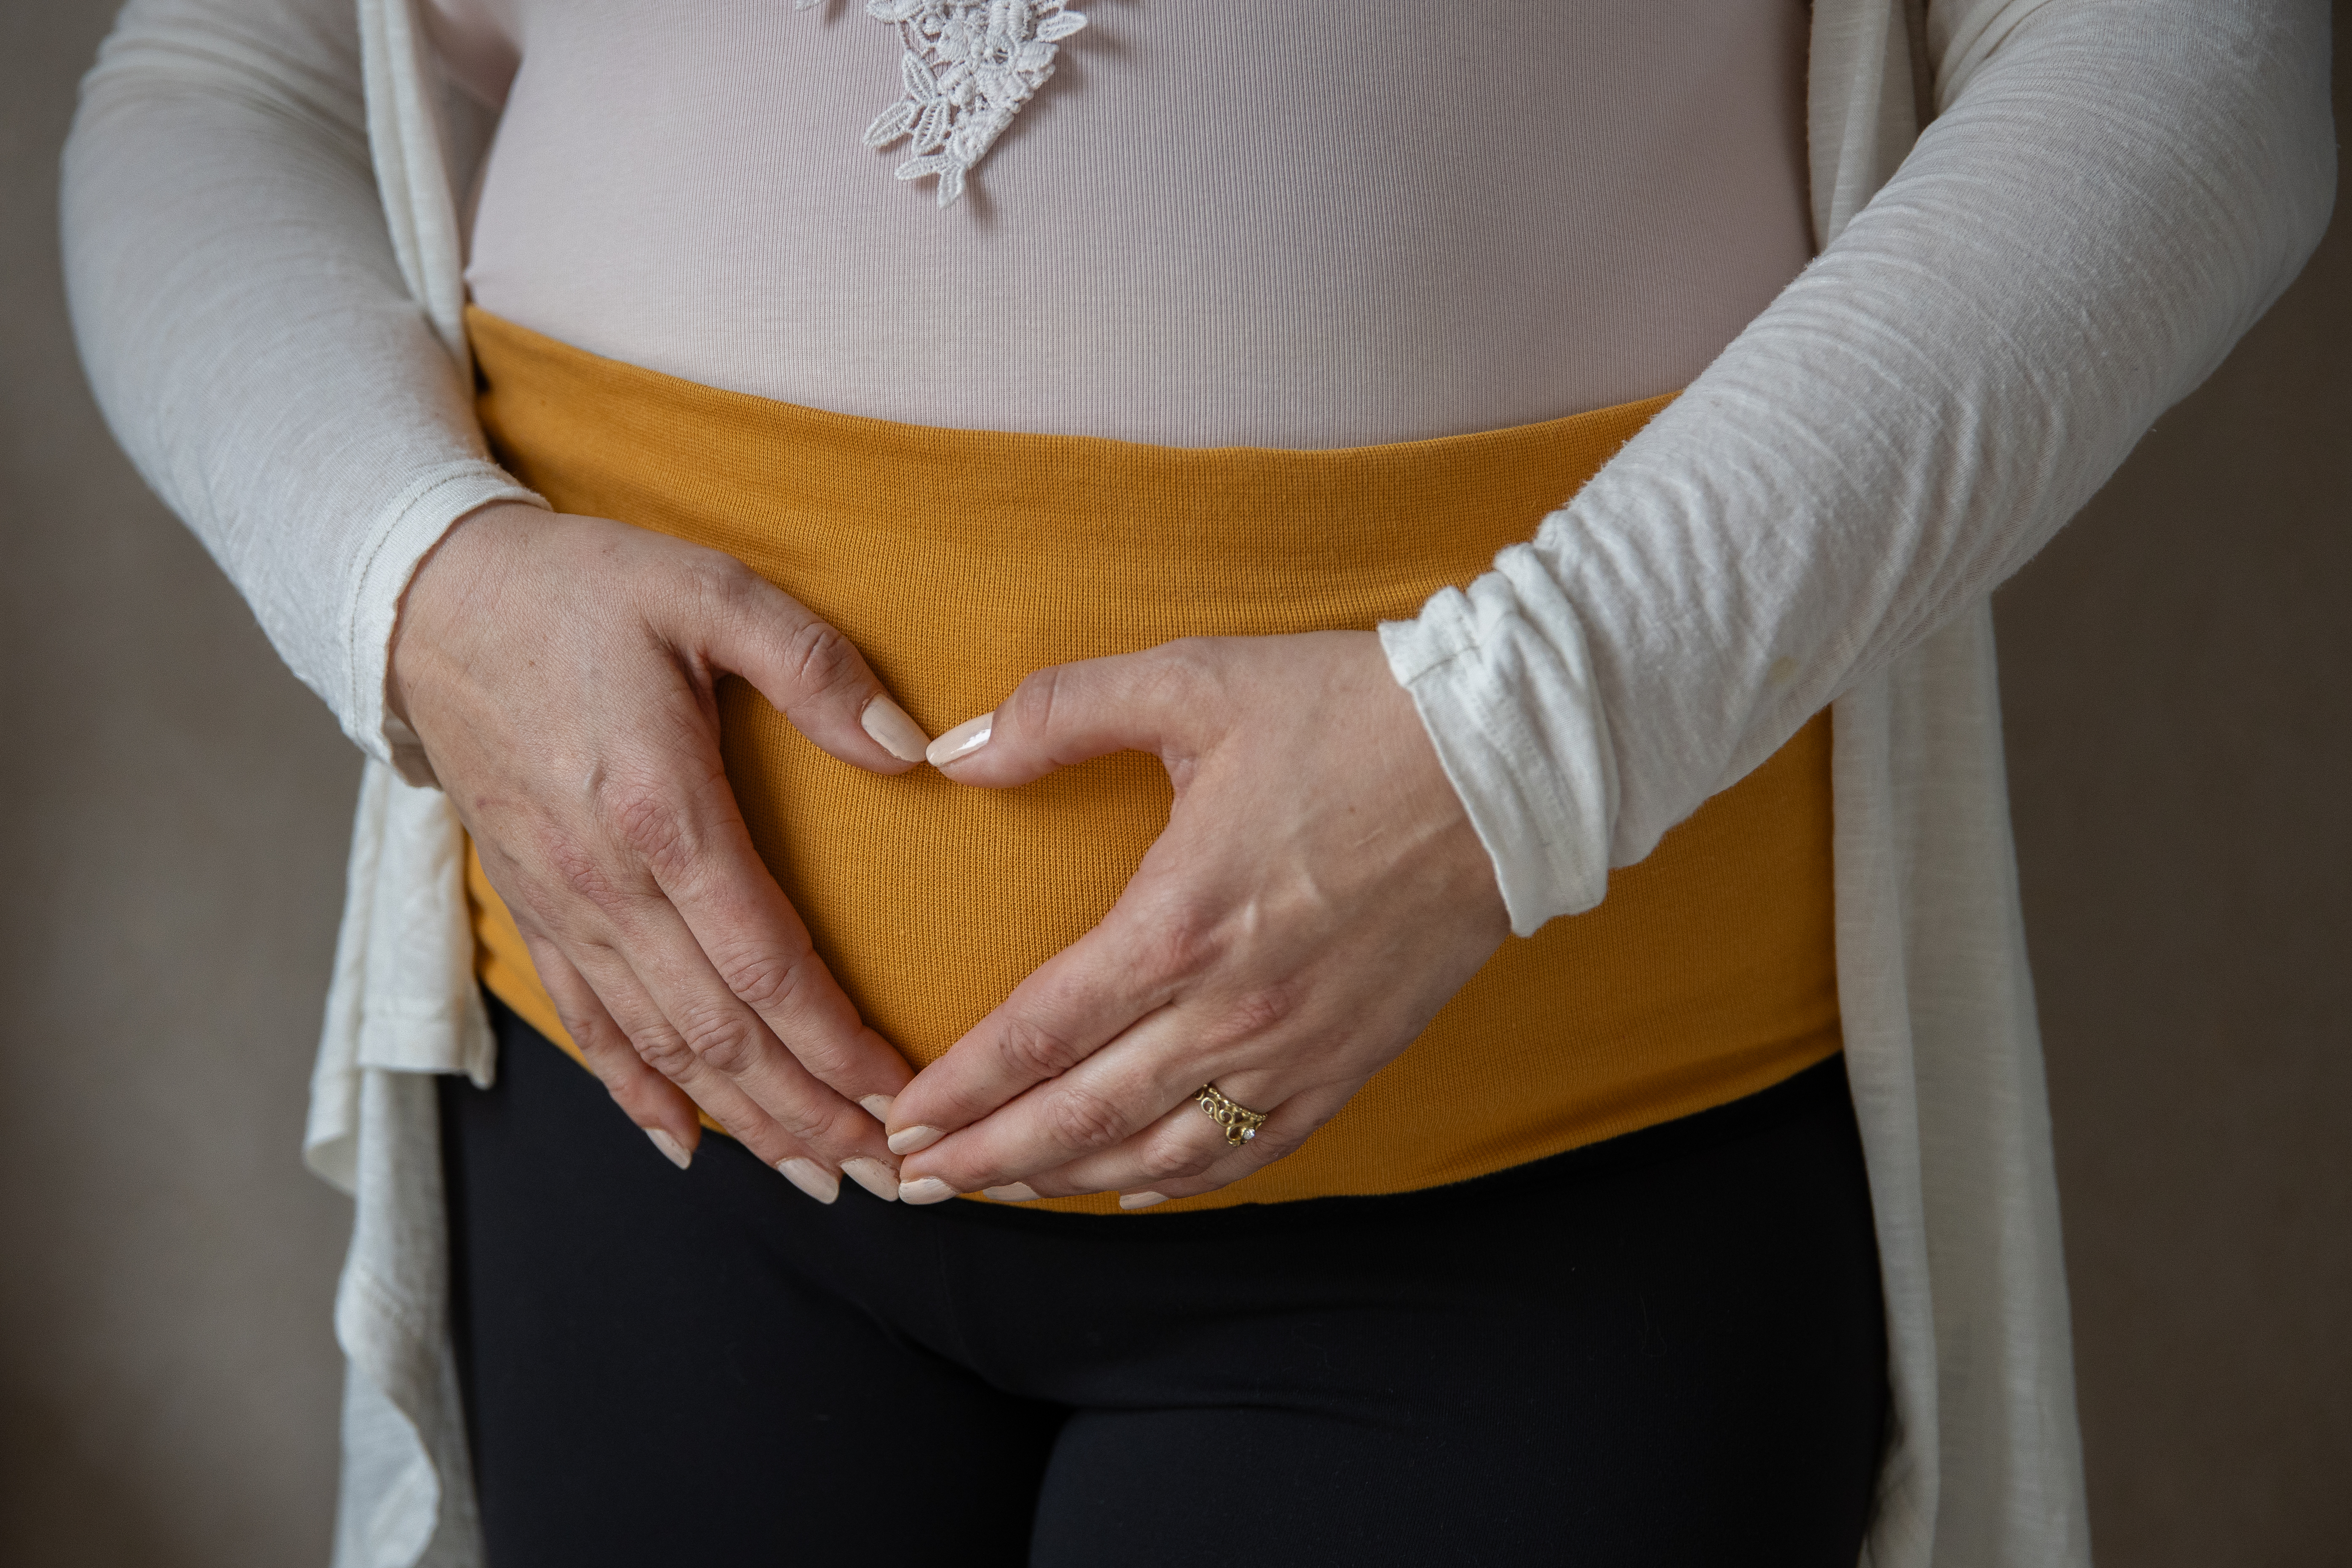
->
<box><xmin>428</xmin><ymin>0</ymin><xmax>1811</xmax><ymax>447</ymax></box>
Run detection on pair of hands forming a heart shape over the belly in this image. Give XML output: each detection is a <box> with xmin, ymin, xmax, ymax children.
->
<box><xmin>390</xmin><ymin>505</ymin><xmax>1510</xmax><ymax>1206</ymax></box>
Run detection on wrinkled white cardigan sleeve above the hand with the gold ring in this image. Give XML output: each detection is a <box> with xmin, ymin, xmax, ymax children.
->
<box><xmin>1380</xmin><ymin>0</ymin><xmax>2336</xmax><ymax>936</ymax></box>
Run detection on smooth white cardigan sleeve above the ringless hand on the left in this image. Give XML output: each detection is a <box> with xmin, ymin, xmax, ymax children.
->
<box><xmin>64</xmin><ymin>0</ymin><xmax>539</xmax><ymax>778</ymax></box>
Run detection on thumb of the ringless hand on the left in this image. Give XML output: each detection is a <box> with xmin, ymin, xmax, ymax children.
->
<box><xmin>703</xmin><ymin>569</ymin><xmax>929</xmax><ymax>773</ymax></box>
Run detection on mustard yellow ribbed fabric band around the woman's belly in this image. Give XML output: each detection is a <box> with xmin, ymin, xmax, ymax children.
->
<box><xmin>468</xmin><ymin>310</ymin><xmax>1839</xmax><ymax>1213</ymax></box>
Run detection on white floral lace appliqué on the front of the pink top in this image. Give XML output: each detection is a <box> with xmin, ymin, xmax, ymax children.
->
<box><xmin>793</xmin><ymin>0</ymin><xmax>1087</xmax><ymax>207</ymax></box>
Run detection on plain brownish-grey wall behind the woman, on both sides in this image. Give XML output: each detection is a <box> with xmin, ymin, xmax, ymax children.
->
<box><xmin>0</xmin><ymin>0</ymin><xmax>2352</xmax><ymax>1568</ymax></box>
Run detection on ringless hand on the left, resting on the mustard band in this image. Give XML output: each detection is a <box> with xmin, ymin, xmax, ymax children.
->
<box><xmin>388</xmin><ymin>503</ymin><xmax>924</xmax><ymax>1201</ymax></box>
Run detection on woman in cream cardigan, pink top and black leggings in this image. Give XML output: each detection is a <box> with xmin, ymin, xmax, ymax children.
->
<box><xmin>66</xmin><ymin>0</ymin><xmax>2333</xmax><ymax>1568</ymax></box>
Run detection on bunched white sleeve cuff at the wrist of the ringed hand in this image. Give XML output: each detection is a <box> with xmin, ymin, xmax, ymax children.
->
<box><xmin>1380</xmin><ymin>545</ymin><xmax>1616</xmax><ymax>936</ymax></box>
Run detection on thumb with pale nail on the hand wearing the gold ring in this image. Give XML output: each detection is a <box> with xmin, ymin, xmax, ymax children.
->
<box><xmin>929</xmin><ymin>639</ymin><xmax>1216</xmax><ymax>788</ymax></box>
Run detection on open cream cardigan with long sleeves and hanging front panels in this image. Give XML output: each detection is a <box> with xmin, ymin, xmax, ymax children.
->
<box><xmin>66</xmin><ymin>0</ymin><xmax>2333</xmax><ymax>1568</ymax></box>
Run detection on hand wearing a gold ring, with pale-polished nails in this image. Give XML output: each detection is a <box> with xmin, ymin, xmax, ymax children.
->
<box><xmin>889</xmin><ymin>632</ymin><xmax>1510</xmax><ymax>1208</ymax></box>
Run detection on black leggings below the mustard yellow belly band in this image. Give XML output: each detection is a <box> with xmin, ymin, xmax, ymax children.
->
<box><xmin>442</xmin><ymin>1009</ymin><xmax>1886</xmax><ymax>1568</ymax></box>
